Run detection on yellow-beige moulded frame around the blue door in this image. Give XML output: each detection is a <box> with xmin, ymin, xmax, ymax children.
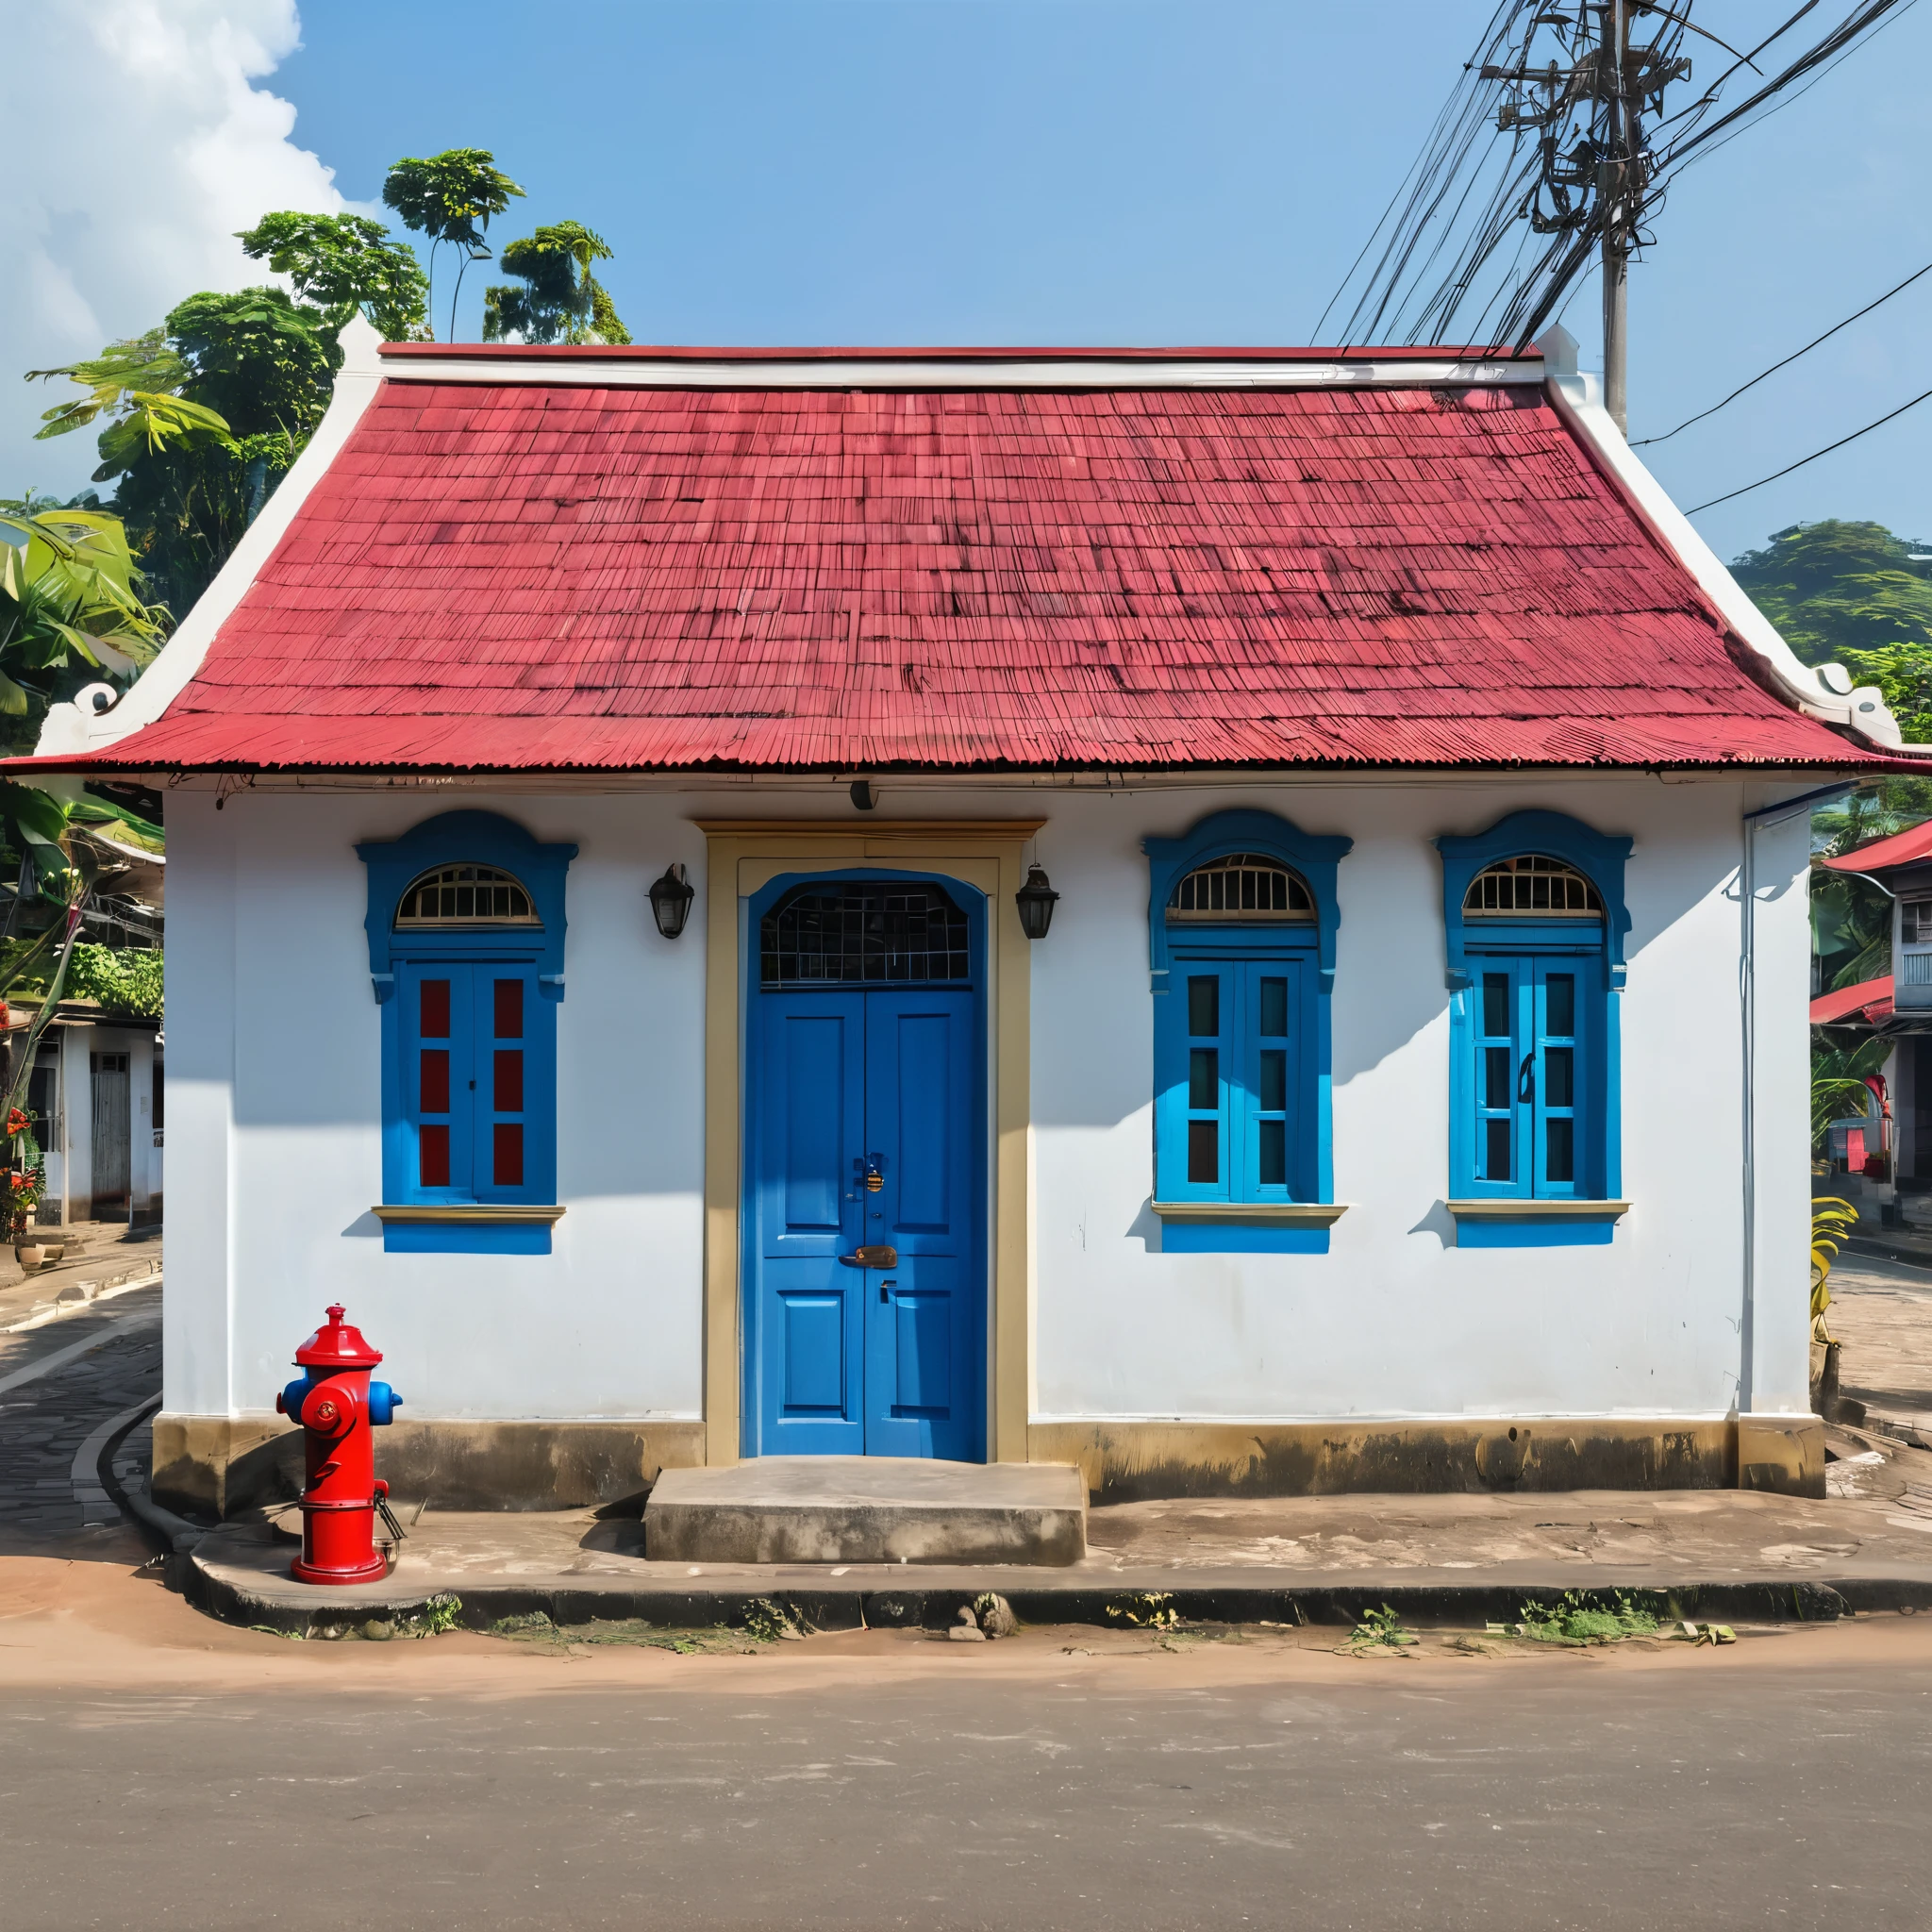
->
<box><xmin>695</xmin><ymin>819</ymin><xmax>1045</xmax><ymax>1464</ymax></box>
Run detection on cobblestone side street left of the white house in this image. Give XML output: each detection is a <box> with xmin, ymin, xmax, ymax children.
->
<box><xmin>0</xmin><ymin>1283</ymin><xmax>160</xmax><ymax>1557</ymax></box>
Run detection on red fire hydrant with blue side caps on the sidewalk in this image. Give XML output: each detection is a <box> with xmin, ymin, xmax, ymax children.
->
<box><xmin>275</xmin><ymin>1302</ymin><xmax>402</xmax><ymax>1582</ymax></box>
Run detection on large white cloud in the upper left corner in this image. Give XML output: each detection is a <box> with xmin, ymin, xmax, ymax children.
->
<box><xmin>0</xmin><ymin>0</ymin><xmax>344</xmax><ymax>496</ymax></box>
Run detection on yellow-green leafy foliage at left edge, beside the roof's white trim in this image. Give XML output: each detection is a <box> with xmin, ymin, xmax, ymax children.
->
<box><xmin>0</xmin><ymin>496</ymin><xmax>168</xmax><ymax>746</ymax></box>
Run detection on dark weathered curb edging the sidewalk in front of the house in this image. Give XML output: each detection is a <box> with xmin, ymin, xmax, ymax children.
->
<box><xmin>186</xmin><ymin>1549</ymin><xmax>1932</xmax><ymax>1637</ymax></box>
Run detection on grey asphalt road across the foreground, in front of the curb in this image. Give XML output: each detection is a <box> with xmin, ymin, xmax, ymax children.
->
<box><xmin>0</xmin><ymin>1639</ymin><xmax>1932</xmax><ymax>1932</ymax></box>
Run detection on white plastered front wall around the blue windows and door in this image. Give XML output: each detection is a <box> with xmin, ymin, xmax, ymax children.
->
<box><xmin>164</xmin><ymin>776</ymin><xmax>1808</xmax><ymax>1420</ymax></box>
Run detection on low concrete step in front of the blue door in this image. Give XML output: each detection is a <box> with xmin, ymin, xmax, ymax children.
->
<box><xmin>643</xmin><ymin>1455</ymin><xmax>1086</xmax><ymax>1565</ymax></box>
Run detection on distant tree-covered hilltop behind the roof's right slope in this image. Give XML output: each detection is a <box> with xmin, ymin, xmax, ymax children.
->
<box><xmin>1731</xmin><ymin>518</ymin><xmax>1932</xmax><ymax>668</ymax></box>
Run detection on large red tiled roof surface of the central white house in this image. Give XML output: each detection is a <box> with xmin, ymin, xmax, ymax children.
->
<box><xmin>8</xmin><ymin>365</ymin><xmax>1884</xmax><ymax>771</ymax></box>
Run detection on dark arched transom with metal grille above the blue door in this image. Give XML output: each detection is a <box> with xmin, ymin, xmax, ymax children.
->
<box><xmin>758</xmin><ymin>879</ymin><xmax>972</xmax><ymax>988</ymax></box>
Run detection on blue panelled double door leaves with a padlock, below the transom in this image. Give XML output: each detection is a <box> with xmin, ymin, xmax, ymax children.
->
<box><xmin>748</xmin><ymin>988</ymin><xmax>985</xmax><ymax>1460</ymax></box>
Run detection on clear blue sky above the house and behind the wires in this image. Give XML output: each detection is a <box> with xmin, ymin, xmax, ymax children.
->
<box><xmin>6</xmin><ymin>0</ymin><xmax>1932</xmax><ymax>557</ymax></box>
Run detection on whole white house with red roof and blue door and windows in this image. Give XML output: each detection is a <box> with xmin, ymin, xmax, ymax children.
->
<box><xmin>25</xmin><ymin>323</ymin><xmax>1901</xmax><ymax>1507</ymax></box>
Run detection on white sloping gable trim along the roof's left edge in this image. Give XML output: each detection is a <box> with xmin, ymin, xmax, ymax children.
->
<box><xmin>35</xmin><ymin>315</ymin><xmax>383</xmax><ymax>758</ymax></box>
